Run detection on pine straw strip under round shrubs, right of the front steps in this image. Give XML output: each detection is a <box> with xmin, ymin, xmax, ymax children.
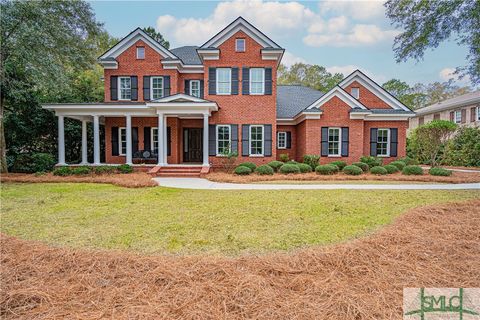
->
<box><xmin>203</xmin><ymin>171</ymin><xmax>480</xmax><ymax>183</ymax></box>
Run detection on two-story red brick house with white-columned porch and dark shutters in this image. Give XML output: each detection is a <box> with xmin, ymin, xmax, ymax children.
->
<box><xmin>44</xmin><ymin>17</ymin><xmax>414</xmax><ymax>172</ymax></box>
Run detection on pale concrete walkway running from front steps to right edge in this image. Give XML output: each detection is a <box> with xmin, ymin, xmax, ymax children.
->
<box><xmin>153</xmin><ymin>178</ymin><xmax>480</xmax><ymax>190</ymax></box>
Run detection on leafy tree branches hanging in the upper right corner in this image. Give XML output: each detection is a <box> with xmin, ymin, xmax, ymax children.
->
<box><xmin>385</xmin><ymin>0</ymin><xmax>480</xmax><ymax>84</ymax></box>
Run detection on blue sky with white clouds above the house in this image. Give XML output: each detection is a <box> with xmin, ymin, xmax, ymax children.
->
<box><xmin>90</xmin><ymin>0</ymin><xmax>469</xmax><ymax>85</ymax></box>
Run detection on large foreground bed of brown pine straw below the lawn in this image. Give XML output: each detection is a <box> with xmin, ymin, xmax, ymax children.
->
<box><xmin>0</xmin><ymin>200</ymin><xmax>480</xmax><ymax>320</ymax></box>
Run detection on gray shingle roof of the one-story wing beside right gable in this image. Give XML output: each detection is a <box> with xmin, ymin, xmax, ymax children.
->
<box><xmin>277</xmin><ymin>85</ymin><xmax>323</xmax><ymax>119</ymax></box>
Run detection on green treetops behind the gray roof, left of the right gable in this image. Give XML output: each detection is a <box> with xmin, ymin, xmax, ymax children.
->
<box><xmin>277</xmin><ymin>63</ymin><xmax>343</xmax><ymax>92</ymax></box>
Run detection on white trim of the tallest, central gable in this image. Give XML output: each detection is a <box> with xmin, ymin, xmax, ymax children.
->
<box><xmin>201</xmin><ymin>17</ymin><xmax>281</xmax><ymax>50</ymax></box>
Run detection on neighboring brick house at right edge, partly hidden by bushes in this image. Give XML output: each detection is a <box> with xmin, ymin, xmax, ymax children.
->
<box><xmin>409</xmin><ymin>91</ymin><xmax>480</xmax><ymax>130</ymax></box>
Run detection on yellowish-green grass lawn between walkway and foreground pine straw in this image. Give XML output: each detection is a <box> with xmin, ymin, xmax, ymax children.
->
<box><xmin>0</xmin><ymin>183</ymin><xmax>480</xmax><ymax>255</ymax></box>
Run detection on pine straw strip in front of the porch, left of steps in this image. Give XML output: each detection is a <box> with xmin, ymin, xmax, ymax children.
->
<box><xmin>1</xmin><ymin>172</ymin><xmax>157</xmax><ymax>188</ymax></box>
